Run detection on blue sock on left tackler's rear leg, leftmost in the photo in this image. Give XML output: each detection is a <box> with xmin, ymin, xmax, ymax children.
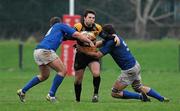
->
<box><xmin>22</xmin><ymin>76</ymin><xmax>41</xmax><ymax>93</ymax></box>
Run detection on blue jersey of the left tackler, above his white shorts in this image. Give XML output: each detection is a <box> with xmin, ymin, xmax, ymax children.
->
<box><xmin>36</xmin><ymin>23</ymin><xmax>75</xmax><ymax>51</ymax></box>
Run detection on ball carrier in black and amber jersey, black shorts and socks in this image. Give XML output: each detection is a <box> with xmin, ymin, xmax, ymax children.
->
<box><xmin>74</xmin><ymin>9</ymin><xmax>102</xmax><ymax>102</ymax></box>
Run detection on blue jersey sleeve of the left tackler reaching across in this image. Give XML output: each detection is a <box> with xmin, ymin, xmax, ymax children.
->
<box><xmin>62</xmin><ymin>24</ymin><xmax>76</xmax><ymax>37</ymax></box>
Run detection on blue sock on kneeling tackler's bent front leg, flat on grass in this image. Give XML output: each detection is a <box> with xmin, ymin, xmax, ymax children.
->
<box><xmin>123</xmin><ymin>90</ymin><xmax>141</xmax><ymax>99</ymax></box>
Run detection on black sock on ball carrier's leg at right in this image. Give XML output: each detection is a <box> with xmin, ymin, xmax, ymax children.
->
<box><xmin>93</xmin><ymin>76</ymin><xmax>101</xmax><ymax>94</ymax></box>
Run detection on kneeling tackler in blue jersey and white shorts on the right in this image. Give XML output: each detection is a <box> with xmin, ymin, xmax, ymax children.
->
<box><xmin>78</xmin><ymin>24</ymin><xmax>169</xmax><ymax>102</ymax></box>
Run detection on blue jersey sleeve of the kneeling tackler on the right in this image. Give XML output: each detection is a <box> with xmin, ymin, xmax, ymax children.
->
<box><xmin>99</xmin><ymin>40</ymin><xmax>115</xmax><ymax>55</ymax></box>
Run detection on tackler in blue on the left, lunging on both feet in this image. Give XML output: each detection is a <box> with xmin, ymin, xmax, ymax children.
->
<box><xmin>17</xmin><ymin>17</ymin><xmax>94</xmax><ymax>102</ymax></box>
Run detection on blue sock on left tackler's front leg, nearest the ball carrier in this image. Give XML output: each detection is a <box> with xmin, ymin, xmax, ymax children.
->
<box><xmin>49</xmin><ymin>74</ymin><xmax>64</xmax><ymax>97</ymax></box>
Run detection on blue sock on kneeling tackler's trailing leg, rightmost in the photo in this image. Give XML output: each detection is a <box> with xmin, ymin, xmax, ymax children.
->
<box><xmin>147</xmin><ymin>89</ymin><xmax>164</xmax><ymax>101</ymax></box>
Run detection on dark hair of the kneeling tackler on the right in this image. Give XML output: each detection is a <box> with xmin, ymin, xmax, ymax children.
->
<box><xmin>102</xmin><ymin>24</ymin><xmax>116</xmax><ymax>35</ymax></box>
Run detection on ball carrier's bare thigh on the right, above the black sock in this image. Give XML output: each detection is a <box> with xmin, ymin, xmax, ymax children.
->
<box><xmin>88</xmin><ymin>61</ymin><xmax>100</xmax><ymax>77</ymax></box>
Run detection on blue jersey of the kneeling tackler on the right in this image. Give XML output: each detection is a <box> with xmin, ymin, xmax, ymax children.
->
<box><xmin>100</xmin><ymin>37</ymin><xmax>136</xmax><ymax>70</ymax></box>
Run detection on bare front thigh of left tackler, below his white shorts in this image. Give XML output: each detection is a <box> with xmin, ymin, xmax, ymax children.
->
<box><xmin>48</xmin><ymin>57</ymin><xmax>66</xmax><ymax>76</ymax></box>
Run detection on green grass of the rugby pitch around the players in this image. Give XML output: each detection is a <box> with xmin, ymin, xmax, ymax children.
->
<box><xmin>0</xmin><ymin>39</ymin><xmax>180</xmax><ymax>111</ymax></box>
